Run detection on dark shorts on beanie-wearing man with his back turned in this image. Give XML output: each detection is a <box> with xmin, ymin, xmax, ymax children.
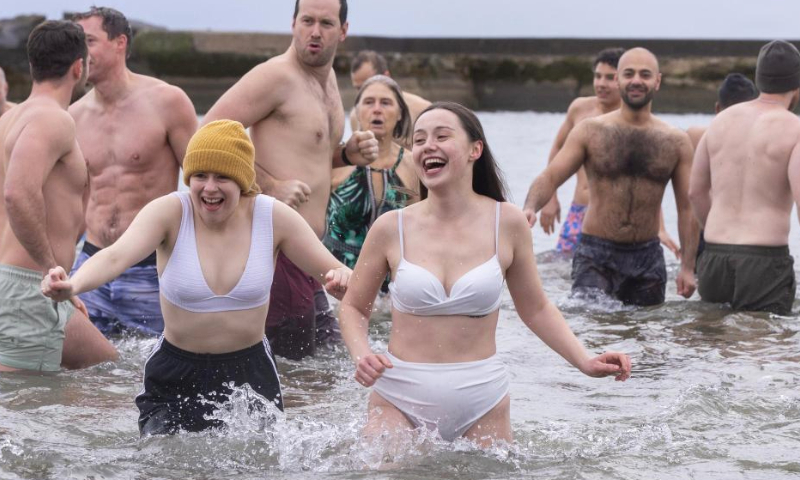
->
<box><xmin>697</xmin><ymin>242</ymin><xmax>797</xmax><ymax>315</ymax></box>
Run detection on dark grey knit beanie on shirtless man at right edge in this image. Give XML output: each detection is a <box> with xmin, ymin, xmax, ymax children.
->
<box><xmin>756</xmin><ymin>40</ymin><xmax>800</xmax><ymax>93</ymax></box>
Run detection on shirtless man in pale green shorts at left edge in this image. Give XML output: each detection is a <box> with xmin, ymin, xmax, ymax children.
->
<box><xmin>0</xmin><ymin>22</ymin><xmax>117</xmax><ymax>372</ymax></box>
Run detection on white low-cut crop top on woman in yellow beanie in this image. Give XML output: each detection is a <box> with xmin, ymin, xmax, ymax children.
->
<box><xmin>159</xmin><ymin>192</ymin><xmax>275</xmax><ymax>312</ymax></box>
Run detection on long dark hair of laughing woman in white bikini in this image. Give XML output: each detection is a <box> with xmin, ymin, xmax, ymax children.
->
<box><xmin>417</xmin><ymin>102</ymin><xmax>508</xmax><ymax>202</ymax></box>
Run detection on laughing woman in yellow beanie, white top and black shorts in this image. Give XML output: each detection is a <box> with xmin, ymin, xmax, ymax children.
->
<box><xmin>42</xmin><ymin>120</ymin><xmax>351</xmax><ymax>435</ymax></box>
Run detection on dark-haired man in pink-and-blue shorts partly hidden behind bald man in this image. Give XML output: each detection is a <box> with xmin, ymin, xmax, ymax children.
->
<box><xmin>539</xmin><ymin>48</ymin><xmax>679</xmax><ymax>255</ymax></box>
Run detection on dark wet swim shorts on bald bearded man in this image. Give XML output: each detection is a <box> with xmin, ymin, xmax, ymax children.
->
<box><xmin>572</xmin><ymin>233</ymin><xmax>667</xmax><ymax>306</ymax></box>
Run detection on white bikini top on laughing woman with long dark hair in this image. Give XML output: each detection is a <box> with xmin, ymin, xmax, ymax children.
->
<box><xmin>389</xmin><ymin>202</ymin><xmax>504</xmax><ymax>317</ymax></box>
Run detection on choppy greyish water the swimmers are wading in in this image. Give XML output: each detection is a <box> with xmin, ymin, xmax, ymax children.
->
<box><xmin>0</xmin><ymin>113</ymin><xmax>800</xmax><ymax>480</ymax></box>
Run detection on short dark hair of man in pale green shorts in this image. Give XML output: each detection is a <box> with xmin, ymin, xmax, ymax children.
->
<box><xmin>28</xmin><ymin>20</ymin><xmax>87</xmax><ymax>82</ymax></box>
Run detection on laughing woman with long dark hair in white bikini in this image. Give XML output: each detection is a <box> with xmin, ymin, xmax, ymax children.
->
<box><xmin>340</xmin><ymin>103</ymin><xmax>631</xmax><ymax>445</ymax></box>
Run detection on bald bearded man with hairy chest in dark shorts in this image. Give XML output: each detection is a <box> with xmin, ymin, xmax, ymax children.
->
<box><xmin>525</xmin><ymin>48</ymin><xmax>697</xmax><ymax>305</ymax></box>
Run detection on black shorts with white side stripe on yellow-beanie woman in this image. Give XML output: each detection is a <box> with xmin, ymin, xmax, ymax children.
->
<box><xmin>136</xmin><ymin>337</ymin><xmax>283</xmax><ymax>436</ymax></box>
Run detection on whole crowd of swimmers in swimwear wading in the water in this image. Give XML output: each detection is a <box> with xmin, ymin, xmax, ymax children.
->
<box><xmin>0</xmin><ymin>0</ymin><xmax>800</xmax><ymax>445</ymax></box>
